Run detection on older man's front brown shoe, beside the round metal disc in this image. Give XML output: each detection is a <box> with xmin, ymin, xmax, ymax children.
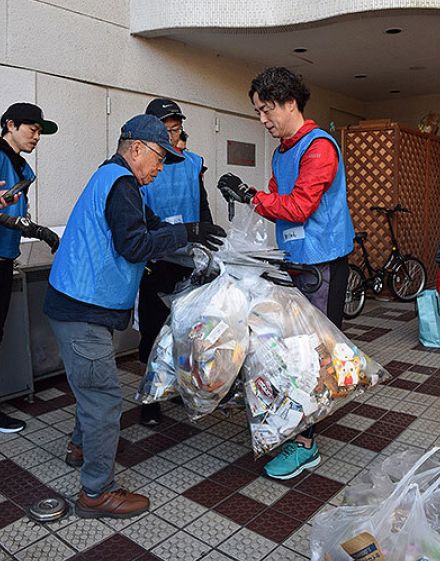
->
<box><xmin>75</xmin><ymin>489</ymin><xmax>150</xmax><ymax>518</ymax></box>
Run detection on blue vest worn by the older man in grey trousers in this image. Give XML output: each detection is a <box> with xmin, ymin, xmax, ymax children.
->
<box><xmin>49</xmin><ymin>164</ymin><xmax>145</xmax><ymax>310</ymax></box>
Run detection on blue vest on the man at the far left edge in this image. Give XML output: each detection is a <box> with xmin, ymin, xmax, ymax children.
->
<box><xmin>0</xmin><ymin>151</ymin><xmax>35</xmax><ymax>259</ymax></box>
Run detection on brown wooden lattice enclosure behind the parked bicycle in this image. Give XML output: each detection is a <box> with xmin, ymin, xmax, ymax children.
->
<box><xmin>342</xmin><ymin>122</ymin><xmax>440</xmax><ymax>286</ymax></box>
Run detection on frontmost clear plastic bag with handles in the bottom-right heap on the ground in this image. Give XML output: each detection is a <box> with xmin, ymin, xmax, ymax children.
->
<box><xmin>310</xmin><ymin>448</ymin><xmax>440</xmax><ymax>561</ymax></box>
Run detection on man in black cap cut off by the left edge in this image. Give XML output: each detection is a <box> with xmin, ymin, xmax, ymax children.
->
<box><xmin>0</xmin><ymin>103</ymin><xmax>59</xmax><ymax>433</ymax></box>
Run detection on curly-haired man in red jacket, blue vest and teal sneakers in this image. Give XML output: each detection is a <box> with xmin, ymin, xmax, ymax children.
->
<box><xmin>218</xmin><ymin>67</ymin><xmax>354</xmax><ymax>479</ymax></box>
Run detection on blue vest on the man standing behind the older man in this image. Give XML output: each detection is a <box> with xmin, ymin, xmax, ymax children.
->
<box><xmin>140</xmin><ymin>150</ymin><xmax>203</xmax><ymax>224</ymax></box>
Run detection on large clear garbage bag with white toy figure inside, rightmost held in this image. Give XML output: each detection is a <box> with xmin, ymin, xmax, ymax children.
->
<box><xmin>243</xmin><ymin>279</ymin><xmax>387</xmax><ymax>455</ymax></box>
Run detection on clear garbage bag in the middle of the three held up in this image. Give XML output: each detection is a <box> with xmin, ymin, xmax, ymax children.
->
<box><xmin>171</xmin><ymin>273</ymin><xmax>249</xmax><ymax>420</ymax></box>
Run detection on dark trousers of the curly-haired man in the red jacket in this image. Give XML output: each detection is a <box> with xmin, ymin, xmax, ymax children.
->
<box><xmin>293</xmin><ymin>256</ymin><xmax>348</xmax><ymax>438</ymax></box>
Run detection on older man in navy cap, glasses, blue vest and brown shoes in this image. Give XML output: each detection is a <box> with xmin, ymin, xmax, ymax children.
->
<box><xmin>44</xmin><ymin>115</ymin><xmax>225</xmax><ymax>518</ymax></box>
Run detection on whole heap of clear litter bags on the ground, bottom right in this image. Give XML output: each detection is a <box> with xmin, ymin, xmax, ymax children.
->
<box><xmin>310</xmin><ymin>448</ymin><xmax>440</xmax><ymax>561</ymax></box>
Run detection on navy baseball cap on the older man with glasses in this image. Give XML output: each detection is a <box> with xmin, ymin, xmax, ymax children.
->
<box><xmin>121</xmin><ymin>114</ymin><xmax>185</xmax><ymax>164</ymax></box>
